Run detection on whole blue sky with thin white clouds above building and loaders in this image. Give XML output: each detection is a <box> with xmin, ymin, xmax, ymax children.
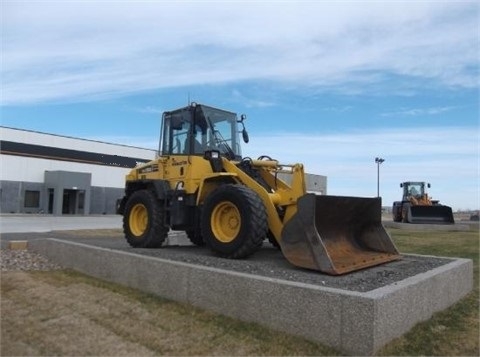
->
<box><xmin>0</xmin><ymin>0</ymin><xmax>480</xmax><ymax>210</ymax></box>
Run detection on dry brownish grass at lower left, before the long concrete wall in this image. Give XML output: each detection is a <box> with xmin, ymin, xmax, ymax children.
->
<box><xmin>1</xmin><ymin>271</ymin><xmax>335</xmax><ymax>356</ymax></box>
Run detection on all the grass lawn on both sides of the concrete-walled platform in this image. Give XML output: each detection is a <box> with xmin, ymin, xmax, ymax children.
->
<box><xmin>0</xmin><ymin>229</ymin><xmax>479</xmax><ymax>356</ymax></box>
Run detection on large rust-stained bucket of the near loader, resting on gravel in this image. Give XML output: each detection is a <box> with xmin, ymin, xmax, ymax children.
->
<box><xmin>280</xmin><ymin>194</ymin><xmax>400</xmax><ymax>275</ymax></box>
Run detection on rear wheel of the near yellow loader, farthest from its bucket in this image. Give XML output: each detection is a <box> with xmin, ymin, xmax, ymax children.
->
<box><xmin>123</xmin><ymin>190</ymin><xmax>169</xmax><ymax>248</ymax></box>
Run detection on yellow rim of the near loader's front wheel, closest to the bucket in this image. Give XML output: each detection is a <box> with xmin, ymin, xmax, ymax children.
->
<box><xmin>210</xmin><ymin>201</ymin><xmax>242</xmax><ymax>243</ymax></box>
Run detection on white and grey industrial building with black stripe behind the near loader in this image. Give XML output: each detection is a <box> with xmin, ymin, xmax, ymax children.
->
<box><xmin>0</xmin><ymin>126</ymin><xmax>327</xmax><ymax>215</ymax></box>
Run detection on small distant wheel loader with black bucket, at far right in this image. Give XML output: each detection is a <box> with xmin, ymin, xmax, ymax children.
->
<box><xmin>392</xmin><ymin>181</ymin><xmax>455</xmax><ymax>224</ymax></box>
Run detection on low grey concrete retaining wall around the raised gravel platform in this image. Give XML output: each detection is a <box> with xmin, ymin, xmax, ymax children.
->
<box><xmin>29</xmin><ymin>239</ymin><xmax>473</xmax><ymax>355</ymax></box>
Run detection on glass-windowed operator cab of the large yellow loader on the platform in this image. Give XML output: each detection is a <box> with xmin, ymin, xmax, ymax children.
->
<box><xmin>160</xmin><ymin>103</ymin><xmax>248</xmax><ymax>160</ymax></box>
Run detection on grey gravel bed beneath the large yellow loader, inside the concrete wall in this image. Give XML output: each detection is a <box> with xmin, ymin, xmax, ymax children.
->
<box><xmin>2</xmin><ymin>232</ymin><xmax>452</xmax><ymax>292</ymax></box>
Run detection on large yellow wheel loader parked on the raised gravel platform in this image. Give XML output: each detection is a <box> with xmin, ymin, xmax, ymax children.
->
<box><xmin>117</xmin><ymin>103</ymin><xmax>400</xmax><ymax>275</ymax></box>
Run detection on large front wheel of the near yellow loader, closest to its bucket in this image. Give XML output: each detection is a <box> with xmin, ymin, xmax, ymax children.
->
<box><xmin>200</xmin><ymin>184</ymin><xmax>268</xmax><ymax>259</ymax></box>
